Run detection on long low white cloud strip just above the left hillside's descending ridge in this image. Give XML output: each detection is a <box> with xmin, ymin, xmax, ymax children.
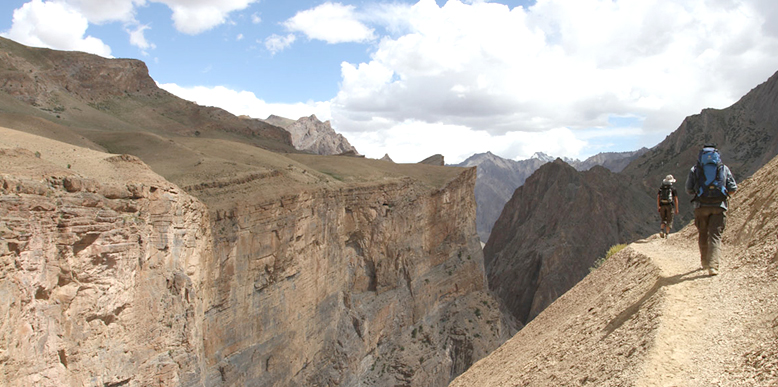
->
<box><xmin>159</xmin><ymin>83</ymin><xmax>331</xmax><ymax>121</ymax></box>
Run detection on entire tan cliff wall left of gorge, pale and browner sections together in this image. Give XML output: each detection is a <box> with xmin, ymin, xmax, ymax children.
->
<box><xmin>0</xmin><ymin>129</ymin><xmax>512</xmax><ymax>386</ymax></box>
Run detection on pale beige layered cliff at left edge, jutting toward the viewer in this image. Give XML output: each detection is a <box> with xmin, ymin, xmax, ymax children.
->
<box><xmin>0</xmin><ymin>141</ymin><xmax>211</xmax><ymax>386</ymax></box>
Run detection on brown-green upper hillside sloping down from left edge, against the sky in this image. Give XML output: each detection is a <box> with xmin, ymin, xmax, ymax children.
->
<box><xmin>0</xmin><ymin>38</ymin><xmax>294</xmax><ymax>152</ymax></box>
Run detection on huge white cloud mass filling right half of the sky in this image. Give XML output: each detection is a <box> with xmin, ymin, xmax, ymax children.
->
<box><xmin>332</xmin><ymin>0</ymin><xmax>778</xmax><ymax>158</ymax></box>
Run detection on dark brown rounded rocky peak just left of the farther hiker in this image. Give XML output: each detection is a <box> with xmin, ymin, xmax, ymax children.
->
<box><xmin>484</xmin><ymin>159</ymin><xmax>656</xmax><ymax>323</ymax></box>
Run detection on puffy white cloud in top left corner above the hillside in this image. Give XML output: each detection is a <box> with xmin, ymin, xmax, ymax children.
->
<box><xmin>0</xmin><ymin>0</ymin><xmax>111</xmax><ymax>57</ymax></box>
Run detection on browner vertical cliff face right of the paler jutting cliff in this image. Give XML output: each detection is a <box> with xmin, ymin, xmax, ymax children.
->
<box><xmin>197</xmin><ymin>165</ymin><xmax>508</xmax><ymax>386</ymax></box>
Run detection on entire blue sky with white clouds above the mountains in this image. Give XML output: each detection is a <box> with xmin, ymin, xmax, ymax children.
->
<box><xmin>0</xmin><ymin>0</ymin><xmax>778</xmax><ymax>164</ymax></box>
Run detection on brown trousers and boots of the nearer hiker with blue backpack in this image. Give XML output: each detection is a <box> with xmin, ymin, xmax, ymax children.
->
<box><xmin>694</xmin><ymin>206</ymin><xmax>727</xmax><ymax>270</ymax></box>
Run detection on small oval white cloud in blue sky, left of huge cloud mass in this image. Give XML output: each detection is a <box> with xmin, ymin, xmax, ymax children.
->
<box><xmin>284</xmin><ymin>2</ymin><xmax>376</xmax><ymax>44</ymax></box>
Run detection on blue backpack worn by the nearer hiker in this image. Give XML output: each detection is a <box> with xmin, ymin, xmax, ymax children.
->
<box><xmin>694</xmin><ymin>145</ymin><xmax>727</xmax><ymax>204</ymax></box>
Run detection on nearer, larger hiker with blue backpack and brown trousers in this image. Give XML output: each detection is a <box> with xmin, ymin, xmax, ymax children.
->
<box><xmin>686</xmin><ymin>144</ymin><xmax>737</xmax><ymax>275</ymax></box>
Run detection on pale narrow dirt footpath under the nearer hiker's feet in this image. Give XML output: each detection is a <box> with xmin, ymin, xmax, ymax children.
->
<box><xmin>631</xmin><ymin>235</ymin><xmax>758</xmax><ymax>387</ymax></box>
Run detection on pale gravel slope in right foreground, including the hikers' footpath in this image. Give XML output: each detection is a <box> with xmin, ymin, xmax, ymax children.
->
<box><xmin>451</xmin><ymin>153</ymin><xmax>778</xmax><ymax>387</ymax></box>
